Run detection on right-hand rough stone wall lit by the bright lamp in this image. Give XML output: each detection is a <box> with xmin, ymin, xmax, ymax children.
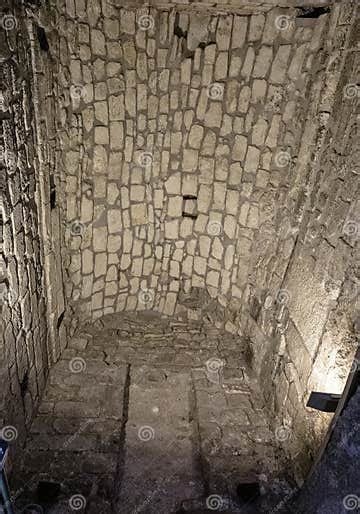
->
<box><xmin>243</xmin><ymin>2</ymin><xmax>360</xmax><ymax>481</ymax></box>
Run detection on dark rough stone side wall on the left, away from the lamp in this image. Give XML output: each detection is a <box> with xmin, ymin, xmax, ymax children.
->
<box><xmin>0</xmin><ymin>3</ymin><xmax>66</xmax><ymax>455</ymax></box>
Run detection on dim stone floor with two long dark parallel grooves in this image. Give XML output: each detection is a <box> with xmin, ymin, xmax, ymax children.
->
<box><xmin>14</xmin><ymin>312</ymin><xmax>280</xmax><ymax>514</ymax></box>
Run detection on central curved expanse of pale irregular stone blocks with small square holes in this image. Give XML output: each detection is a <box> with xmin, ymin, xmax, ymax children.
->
<box><xmin>57</xmin><ymin>0</ymin><xmax>326</xmax><ymax>333</ymax></box>
